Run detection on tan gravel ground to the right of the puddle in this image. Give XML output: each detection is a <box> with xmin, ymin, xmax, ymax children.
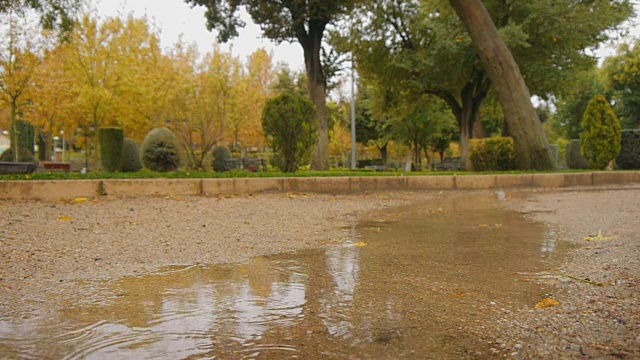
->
<box><xmin>494</xmin><ymin>189</ymin><xmax>640</xmax><ymax>359</ymax></box>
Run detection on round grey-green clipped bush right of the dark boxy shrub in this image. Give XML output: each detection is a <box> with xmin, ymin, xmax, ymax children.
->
<box><xmin>140</xmin><ymin>128</ymin><xmax>180</xmax><ymax>172</ymax></box>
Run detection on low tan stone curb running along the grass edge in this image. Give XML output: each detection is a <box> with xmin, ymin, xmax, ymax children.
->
<box><xmin>0</xmin><ymin>171</ymin><xmax>640</xmax><ymax>201</ymax></box>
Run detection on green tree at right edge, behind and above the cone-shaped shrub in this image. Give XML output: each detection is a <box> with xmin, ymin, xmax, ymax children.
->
<box><xmin>603</xmin><ymin>41</ymin><xmax>640</xmax><ymax>129</ymax></box>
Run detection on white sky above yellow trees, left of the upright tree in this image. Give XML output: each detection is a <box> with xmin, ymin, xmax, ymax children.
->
<box><xmin>92</xmin><ymin>0</ymin><xmax>304</xmax><ymax>70</ymax></box>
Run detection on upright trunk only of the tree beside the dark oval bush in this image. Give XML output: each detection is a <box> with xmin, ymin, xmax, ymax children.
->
<box><xmin>300</xmin><ymin>25</ymin><xmax>329</xmax><ymax>171</ymax></box>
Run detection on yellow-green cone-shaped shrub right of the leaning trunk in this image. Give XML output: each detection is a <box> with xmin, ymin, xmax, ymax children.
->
<box><xmin>580</xmin><ymin>95</ymin><xmax>621</xmax><ymax>170</ymax></box>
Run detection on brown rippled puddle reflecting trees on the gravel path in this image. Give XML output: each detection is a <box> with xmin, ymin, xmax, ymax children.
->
<box><xmin>0</xmin><ymin>196</ymin><xmax>558</xmax><ymax>359</ymax></box>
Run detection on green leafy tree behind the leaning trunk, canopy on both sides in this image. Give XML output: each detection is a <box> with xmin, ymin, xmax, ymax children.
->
<box><xmin>339</xmin><ymin>0</ymin><xmax>631</xmax><ymax>169</ymax></box>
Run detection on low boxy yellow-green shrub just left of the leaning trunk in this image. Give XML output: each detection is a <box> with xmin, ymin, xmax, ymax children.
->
<box><xmin>469</xmin><ymin>138</ymin><xmax>518</xmax><ymax>171</ymax></box>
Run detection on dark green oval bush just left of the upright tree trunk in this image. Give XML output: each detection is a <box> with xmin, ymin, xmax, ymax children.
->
<box><xmin>262</xmin><ymin>93</ymin><xmax>317</xmax><ymax>172</ymax></box>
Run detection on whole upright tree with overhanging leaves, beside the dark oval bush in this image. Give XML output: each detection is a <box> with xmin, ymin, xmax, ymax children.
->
<box><xmin>185</xmin><ymin>0</ymin><xmax>355</xmax><ymax>170</ymax></box>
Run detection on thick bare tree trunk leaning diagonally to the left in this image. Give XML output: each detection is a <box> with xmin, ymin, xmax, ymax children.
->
<box><xmin>449</xmin><ymin>0</ymin><xmax>555</xmax><ymax>170</ymax></box>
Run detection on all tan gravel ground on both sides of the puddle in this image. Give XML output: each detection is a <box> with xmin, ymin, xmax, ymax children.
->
<box><xmin>0</xmin><ymin>188</ymin><xmax>640</xmax><ymax>359</ymax></box>
